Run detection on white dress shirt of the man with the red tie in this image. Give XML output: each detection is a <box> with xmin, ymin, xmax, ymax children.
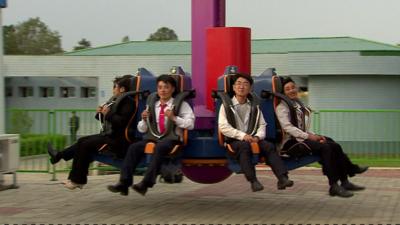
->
<box><xmin>137</xmin><ymin>98</ymin><xmax>195</xmax><ymax>140</ymax></box>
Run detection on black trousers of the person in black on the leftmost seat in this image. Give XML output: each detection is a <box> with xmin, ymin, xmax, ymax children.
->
<box><xmin>67</xmin><ymin>134</ymin><xmax>128</xmax><ymax>184</ymax></box>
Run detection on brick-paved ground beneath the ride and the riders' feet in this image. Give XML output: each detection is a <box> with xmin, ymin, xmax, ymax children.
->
<box><xmin>0</xmin><ymin>169</ymin><xmax>400</xmax><ymax>224</ymax></box>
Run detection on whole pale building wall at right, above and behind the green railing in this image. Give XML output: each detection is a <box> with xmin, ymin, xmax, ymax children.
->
<box><xmin>308</xmin><ymin>75</ymin><xmax>400</xmax><ymax>156</ymax></box>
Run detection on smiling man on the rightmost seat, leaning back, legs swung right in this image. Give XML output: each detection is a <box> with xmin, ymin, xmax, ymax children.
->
<box><xmin>276</xmin><ymin>77</ymin><xmax>368</xmax><ymax>198</ymax></box>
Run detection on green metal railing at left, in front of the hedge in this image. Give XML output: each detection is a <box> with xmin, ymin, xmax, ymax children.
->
<box><xmin>6</xmin><ymin>109</ymin><xmax>100</xmax><ymax>179</ymax></box>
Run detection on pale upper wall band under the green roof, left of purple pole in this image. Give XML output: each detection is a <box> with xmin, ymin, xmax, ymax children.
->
<box><xmin>4</xmin><ymin>55</ymin><xmax>192</xmax><ymax>104</ymax></box>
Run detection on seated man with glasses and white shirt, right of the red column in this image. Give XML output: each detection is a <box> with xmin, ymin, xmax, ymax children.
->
<box><xmin>218</xmin><ymin>74</ymin><xmax>293</xmax><ymax>192</ymax></box>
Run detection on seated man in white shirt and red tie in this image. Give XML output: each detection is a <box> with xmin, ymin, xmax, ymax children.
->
<box><xmin>107</xmin><ymin>75</ymin><xmax>195</xmax><ymax>195</ymax></box>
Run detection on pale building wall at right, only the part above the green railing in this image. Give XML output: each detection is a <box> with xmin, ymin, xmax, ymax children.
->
<box><xmin>308</xmin><ymin>75</ymin><xmax>400</xmax><ymax>109</ymax></box>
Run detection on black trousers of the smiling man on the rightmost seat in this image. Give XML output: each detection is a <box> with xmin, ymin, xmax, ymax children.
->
<box><xmin>284</xmin><ymin>137</ymin><xmax>358</xmax><ymax>185</ymax></box>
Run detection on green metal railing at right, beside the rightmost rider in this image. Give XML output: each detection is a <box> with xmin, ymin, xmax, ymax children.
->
<box><xmin>312</xmin><ymin>109</ymin><xmax>400</xmax><ymax>158</ymax></box>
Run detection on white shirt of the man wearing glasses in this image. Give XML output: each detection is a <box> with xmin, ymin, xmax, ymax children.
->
<box><xmin>218</xmin><ymin>96</ymin><xmax>267</xmax><ymax>141</ymax></box>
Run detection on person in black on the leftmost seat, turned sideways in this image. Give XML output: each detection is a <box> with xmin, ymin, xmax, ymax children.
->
<box><xmin>48</xmin><ymin>76</ymin><xmax>135</xmax><ymax>189</ymax></box>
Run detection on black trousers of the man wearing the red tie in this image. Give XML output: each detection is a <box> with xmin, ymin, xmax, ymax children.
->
<box><xmin>120</xmin><ymin>140</ymin><xmax>180</xmax><ymax>187</ymax></box>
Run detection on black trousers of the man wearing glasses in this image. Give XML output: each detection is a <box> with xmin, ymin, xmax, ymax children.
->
<box><xmin>229</xmin><ymin>140</ymin><xmax>287</xmax><ymax>182</ymax></box>
